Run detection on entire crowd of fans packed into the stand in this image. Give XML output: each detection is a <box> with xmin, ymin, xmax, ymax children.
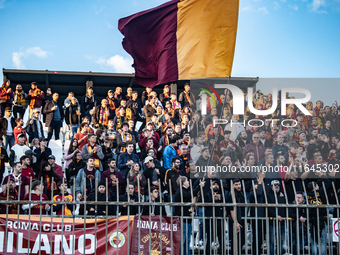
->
<box><xmin>0</xmin><ymin>80</ymin><xmax>340</xmax><ymax>254</ymax></box>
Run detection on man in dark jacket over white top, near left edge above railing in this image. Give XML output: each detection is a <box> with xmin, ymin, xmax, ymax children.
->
<box><xmin>2</xmin><ymin>163</ymin><xmax>30</xmax><ymax>200</ymax></box>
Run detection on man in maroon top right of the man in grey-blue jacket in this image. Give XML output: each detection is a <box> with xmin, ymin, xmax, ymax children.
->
<box><xmin>101</xmin><ymin>159</ymin><xmax>124</xmax><ymax>195</ymax></box>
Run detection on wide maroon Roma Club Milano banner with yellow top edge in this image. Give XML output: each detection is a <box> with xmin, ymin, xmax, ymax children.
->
<box><xmin>0</xmin><ymin>215</ymin><xmax>134</xmax><ymax>255</ymax></box>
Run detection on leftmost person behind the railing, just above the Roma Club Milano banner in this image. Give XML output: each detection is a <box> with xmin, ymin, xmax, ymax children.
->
<box><xmin>0</xmin><ymin>177</ymin><xmax>18</xmax><ymax>214</ymax></box>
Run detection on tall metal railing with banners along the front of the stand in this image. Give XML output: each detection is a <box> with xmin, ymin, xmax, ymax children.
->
<box><xmin>0</xmin><ymin>175</ymin><xmax>340</xmax><ymax>255</ymax></box>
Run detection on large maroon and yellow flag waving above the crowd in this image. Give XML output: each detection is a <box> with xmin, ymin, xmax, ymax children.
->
<box><xmin>118</xmin><ymin>0</ymin><xmax>239</xmax><ymax>88</ymax></box>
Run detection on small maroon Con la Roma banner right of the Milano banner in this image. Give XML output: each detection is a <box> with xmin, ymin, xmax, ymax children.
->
<box><xmin>131</xmin><ymin>216</ymin><xmax>182</xmax><ymax>255</ymax></box>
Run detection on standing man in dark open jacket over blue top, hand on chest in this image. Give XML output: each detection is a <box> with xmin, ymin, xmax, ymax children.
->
<box><xmin>44</xmin><ymin>93</ymin><xmax>64</xmax><ymax>140</ymax></box>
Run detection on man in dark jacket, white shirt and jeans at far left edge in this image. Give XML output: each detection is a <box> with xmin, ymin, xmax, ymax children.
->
<box><xmin>0</xmin><ymin>107</ymin><xmax>16</xmax><ymax>150</ymax></box>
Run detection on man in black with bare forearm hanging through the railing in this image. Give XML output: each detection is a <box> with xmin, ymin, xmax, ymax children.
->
<box><xmin>226</xmin><ymin>178</ymin><xmax>247</xmax><ymax>254</ymax></box>
